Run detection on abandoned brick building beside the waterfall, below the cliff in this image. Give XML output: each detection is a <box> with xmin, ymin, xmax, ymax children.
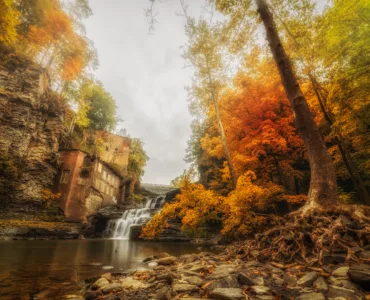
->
<box><xmin>56</xmin><ymin>132</ymin><xmax>134</xmax><ymax>220</ymax></box>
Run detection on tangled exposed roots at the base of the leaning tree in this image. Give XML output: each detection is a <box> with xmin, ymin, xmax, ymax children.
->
<box><xmin>233</xmin><ymin>205</ymin><xmax>370</xmax><ymax>265</ymax></box>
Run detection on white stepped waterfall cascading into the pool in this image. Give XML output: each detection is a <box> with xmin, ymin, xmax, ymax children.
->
<box><xmin>108</xmin><ymin>196</ymin><xmax>165</xmax><ymax>239</ymax></box>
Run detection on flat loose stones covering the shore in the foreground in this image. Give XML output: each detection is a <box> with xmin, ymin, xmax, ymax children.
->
<box><xmin>83</xmin><ymin>247</ymin><xmax>370</xmax><ymax>300</ymax></box>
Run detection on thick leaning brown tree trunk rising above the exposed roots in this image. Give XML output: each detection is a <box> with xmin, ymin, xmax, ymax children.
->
<box><xmin>256</xmin><ymin>0</ymin><xmax>338</xmax><ymax>209</ymax></box>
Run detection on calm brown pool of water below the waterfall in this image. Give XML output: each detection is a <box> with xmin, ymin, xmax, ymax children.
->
<box><xmin>0</xmin><ymin>240</ymin><xmax>208</xmax><ymax>299</ymax></box>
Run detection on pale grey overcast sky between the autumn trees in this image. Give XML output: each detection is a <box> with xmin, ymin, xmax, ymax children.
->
<box><xmin>84</xmin><ymin>0</ymin><xmax>207</xmax><ymax>184</ymax></box>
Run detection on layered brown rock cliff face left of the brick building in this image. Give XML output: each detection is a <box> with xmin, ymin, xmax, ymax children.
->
<box><xmin>0</xmin><ymin>49</ymin><xmax>64</xmax><ymax>208</ymax></box>
